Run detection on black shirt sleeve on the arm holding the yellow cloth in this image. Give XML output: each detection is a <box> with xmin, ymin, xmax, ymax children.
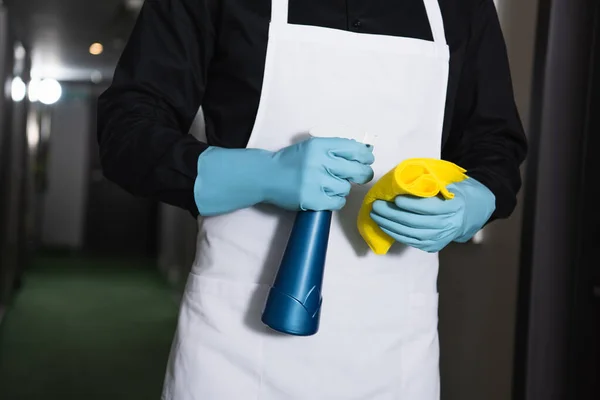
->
<box><xmin>442</xmin><ymin>0</ymin><xmax>527</xmax><ymax>220</ymax></box>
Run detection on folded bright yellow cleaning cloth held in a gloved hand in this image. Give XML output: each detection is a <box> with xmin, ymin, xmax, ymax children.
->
<box><xmin>357</xmin><ymin>158</ymin><xmax>468</xmax><ymax>255</ymax></box>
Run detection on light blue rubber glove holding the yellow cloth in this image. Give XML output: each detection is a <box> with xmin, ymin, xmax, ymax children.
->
<box><xmin>371</xmin><ymin>178</ymin><xmax>496</xmax><ymax>253</ymax></box>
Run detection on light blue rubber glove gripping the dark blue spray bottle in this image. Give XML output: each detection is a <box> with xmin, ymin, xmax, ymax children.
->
<box><xmin>194</xmin><ymin>138</ymin><xmax>375</xmax><ymax>216</ymax></box>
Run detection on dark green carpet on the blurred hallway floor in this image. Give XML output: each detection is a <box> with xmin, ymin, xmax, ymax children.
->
<box><xmin>0</xmin><ymin>258</ymin><xmax>177</xmax><ymax>400</ymax></box>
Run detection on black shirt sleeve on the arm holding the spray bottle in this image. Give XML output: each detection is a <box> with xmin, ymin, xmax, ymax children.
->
<box><xmin>98</xmin><ymin>0</ymin><xmax>215</xmax><ymax>214</ymax></box>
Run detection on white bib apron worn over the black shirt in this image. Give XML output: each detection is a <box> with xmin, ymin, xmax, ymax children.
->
<box><xmin>163</xmin><ymin>0</ymin><xmax>449</xmax><ymax>400</ymax></box>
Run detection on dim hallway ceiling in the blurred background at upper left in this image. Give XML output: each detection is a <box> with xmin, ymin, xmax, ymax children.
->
<box><xmin>4</xmin><ymin>0</ymin><xmax>143</xmax><ymax>81</ymax></box>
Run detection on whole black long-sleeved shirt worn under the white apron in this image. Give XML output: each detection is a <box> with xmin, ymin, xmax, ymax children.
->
<box><xmin>98</xmin><ymin>0</ymin><xmax>527</xmax><ymax>218</ymax></box>
